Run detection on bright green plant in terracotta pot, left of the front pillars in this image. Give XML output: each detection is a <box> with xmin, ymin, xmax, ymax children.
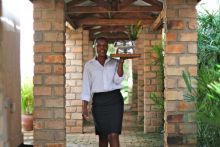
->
<box><xmin>21</xmin><ymin>81</ymin><xmax>34</xmax><ymax>131</ymax></box>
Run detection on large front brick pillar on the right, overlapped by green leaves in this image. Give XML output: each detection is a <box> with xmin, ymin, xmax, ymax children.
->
<box><xmin>164</xmin><ymin>0</ymin><xmax>197</xmax><ymax>146</ymax></box>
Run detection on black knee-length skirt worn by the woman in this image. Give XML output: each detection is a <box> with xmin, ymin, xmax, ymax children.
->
<box><xmin>92</xmin><ymin>89</ymin><xmax>124</xmax><ymax>136</ymax></box>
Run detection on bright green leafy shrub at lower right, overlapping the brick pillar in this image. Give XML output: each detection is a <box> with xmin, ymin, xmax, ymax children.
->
<box><xmin>183</xmin><ymin>67</ymin><xmax>220</xmax><ymax>147</ymax></box>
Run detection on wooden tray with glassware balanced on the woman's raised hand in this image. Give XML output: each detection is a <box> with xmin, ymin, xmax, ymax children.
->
<box><xmin>110</xmin><ymin>41</ymin><xmax>141</xmax><ymax>59</ymax></box>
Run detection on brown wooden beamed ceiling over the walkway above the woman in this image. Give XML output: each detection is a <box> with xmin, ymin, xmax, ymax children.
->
<box><xmin>65</xmin><ymin>0</ymin><xmax>163</xmax><ymax>41</ymax></box>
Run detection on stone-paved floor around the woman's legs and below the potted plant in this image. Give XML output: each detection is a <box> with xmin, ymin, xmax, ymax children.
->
<box><xmin>24</xmin><ymin>104</ymin><xmax>163</xmax><ymax>147</ymax></box>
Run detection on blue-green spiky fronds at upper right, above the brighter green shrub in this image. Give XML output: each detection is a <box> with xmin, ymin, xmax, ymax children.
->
<box><xmin>198</xmin><ymin>10</ymin><xmax>220</xmax><ymax>68</ymax></box>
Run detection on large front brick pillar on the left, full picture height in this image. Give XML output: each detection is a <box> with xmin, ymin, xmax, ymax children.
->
<box><xmin>33</xmin><ymin>0</ymin><xmax>66</xmax><ymax>147</ymax></box>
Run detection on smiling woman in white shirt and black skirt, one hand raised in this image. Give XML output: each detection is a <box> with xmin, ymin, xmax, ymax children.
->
<box><xmin>81</xmin><ymin>37</ymin><xmax>124</xmax><ymax>147</ymax></box>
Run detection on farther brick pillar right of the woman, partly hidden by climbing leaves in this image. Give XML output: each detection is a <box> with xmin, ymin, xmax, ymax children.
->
<box><xmin>144</xmin><ymin>29</ymin><xmax>162</xmax><ymax>132</ymax></box>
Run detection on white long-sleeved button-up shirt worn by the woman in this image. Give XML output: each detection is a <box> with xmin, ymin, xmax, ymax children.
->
<box><xmin>81</xmin><ymin>57</ymin><xmax>124</xmax><ymax>101</ymax></box>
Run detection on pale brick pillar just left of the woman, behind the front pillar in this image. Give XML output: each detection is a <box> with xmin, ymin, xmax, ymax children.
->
<box><xmin>66</xmin><ymin>28</ymin><xmax>83</xmax><ymax>134</ymax></box>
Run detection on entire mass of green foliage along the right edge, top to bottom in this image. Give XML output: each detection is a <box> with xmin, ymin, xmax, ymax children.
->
<box><xmin>183</xmin><ymin>11</ymin><xmax>220</xmax><ymax>147</ymax></box>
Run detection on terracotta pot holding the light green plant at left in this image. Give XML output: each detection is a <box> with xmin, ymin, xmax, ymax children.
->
<box><xmin>21</xmin><ymin>114</ymin><xmax>33</xmax><ymax>131</ymax></box>
